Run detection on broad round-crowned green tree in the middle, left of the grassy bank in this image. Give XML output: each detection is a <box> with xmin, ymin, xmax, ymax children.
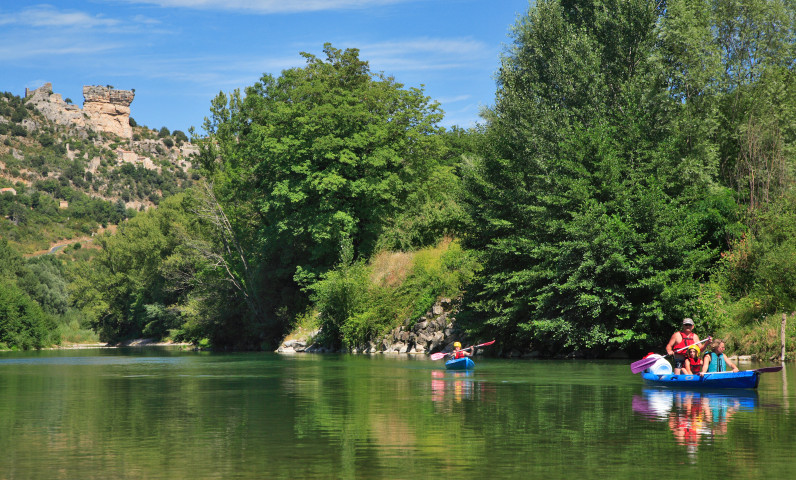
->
<box><xmin>194</xmin><ymin>44</ymin><xmax>447</xmax><ymax>344</ymax></box>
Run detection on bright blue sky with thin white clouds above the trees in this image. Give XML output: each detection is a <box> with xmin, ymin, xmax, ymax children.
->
<box><xmin>0</xmin><ymin>0</ymin><xmax>529</xmax><ymax>133</ymax></box>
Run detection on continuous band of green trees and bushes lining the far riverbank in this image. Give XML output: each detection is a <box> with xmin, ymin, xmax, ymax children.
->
<box><xmin>0</xmin><ymin>0</ymin><xmax>796</xmax><ymax>355</ymax></box>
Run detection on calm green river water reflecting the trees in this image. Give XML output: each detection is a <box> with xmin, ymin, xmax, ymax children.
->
<box><xmin>0</xmin><ymin>349</ymin><xmax>796</xmax><ymax>480</ymax></box>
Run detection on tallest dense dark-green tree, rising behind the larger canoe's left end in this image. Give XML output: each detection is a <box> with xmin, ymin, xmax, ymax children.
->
<box><xmin>465</xmin><ymin>0</ymin><xmax>722</xmax><ymax>353</ymax></box>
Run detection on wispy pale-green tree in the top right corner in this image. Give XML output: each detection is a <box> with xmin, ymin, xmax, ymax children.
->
<box><xmin>709</xmin><ymin>0</ymin><xmax>796</xmax><ymax>215</ymax></box>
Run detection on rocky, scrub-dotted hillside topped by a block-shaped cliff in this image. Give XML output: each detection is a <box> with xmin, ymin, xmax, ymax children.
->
<box><xmin>0</xmin><ymin>84</ymin><xmax>199</xmax><ymax>254</ymax></box>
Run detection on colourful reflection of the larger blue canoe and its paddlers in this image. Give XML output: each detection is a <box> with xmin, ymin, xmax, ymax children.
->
<box><xmin>633</xmin><ymin>389</ymin><xmax>757</xmax><ymax>452</ymax></box>
